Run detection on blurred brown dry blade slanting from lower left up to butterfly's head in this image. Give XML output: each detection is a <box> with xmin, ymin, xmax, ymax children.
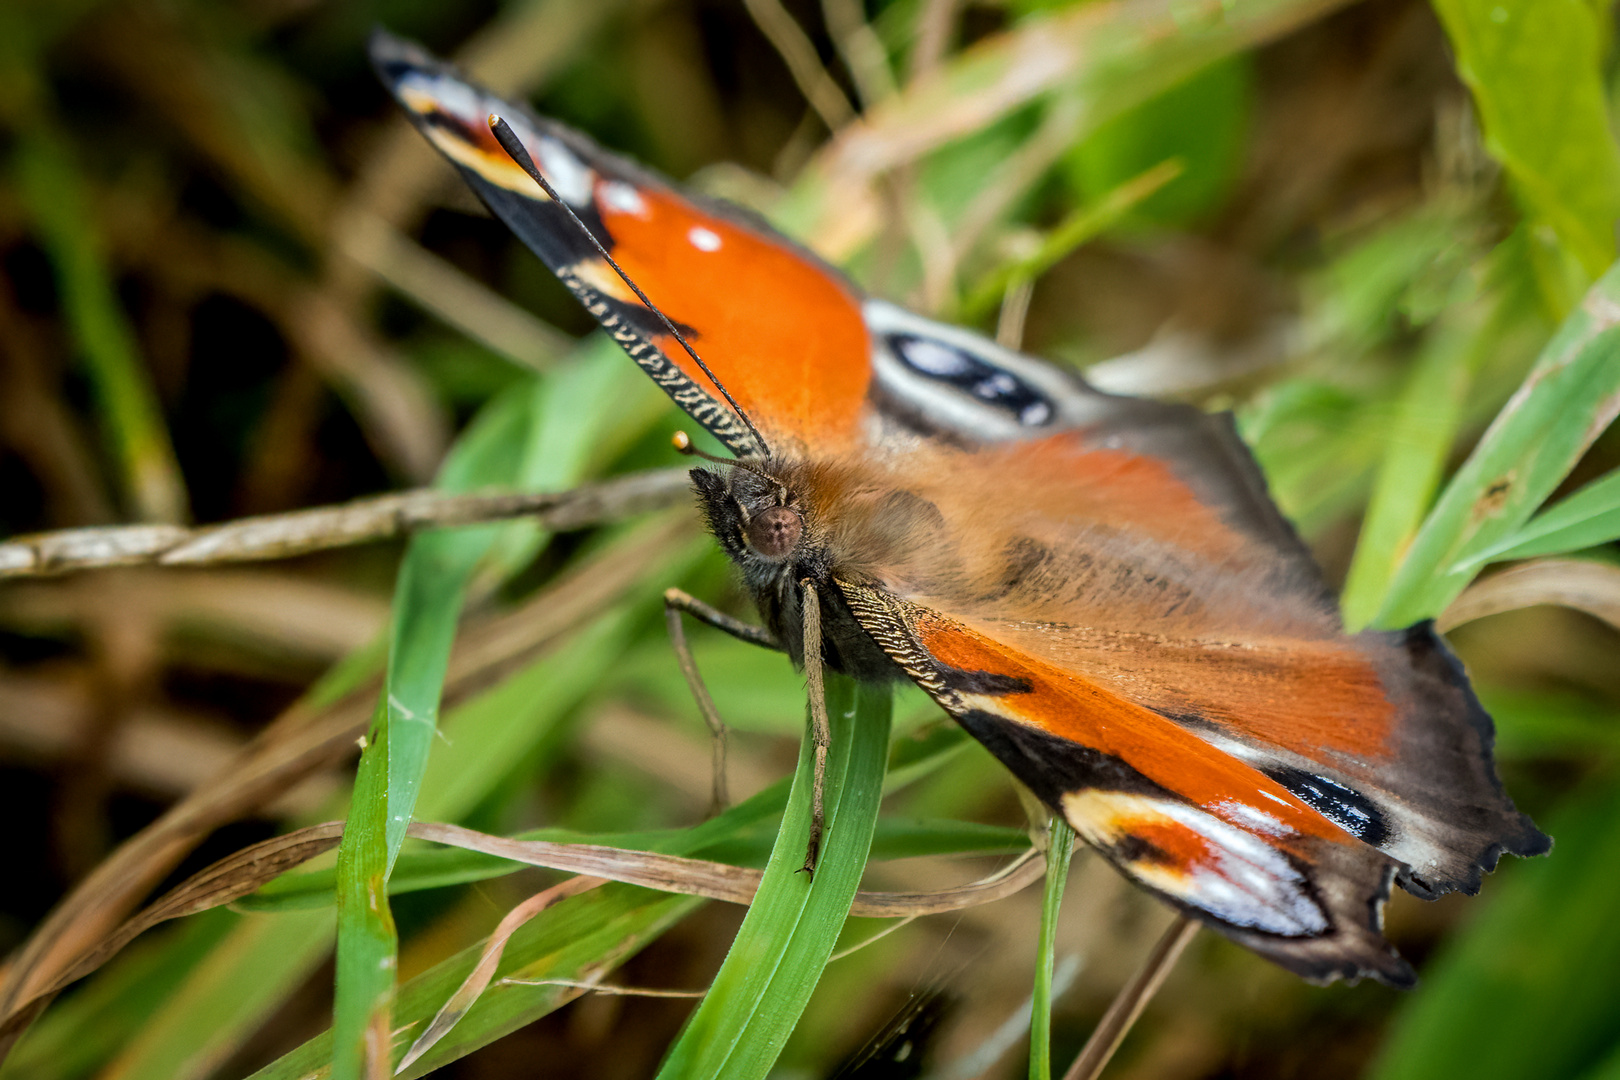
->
<box><xmin>0</xmin><ymin>518</ymin><xmax>692</xmax><ymax>1056</ymax></box>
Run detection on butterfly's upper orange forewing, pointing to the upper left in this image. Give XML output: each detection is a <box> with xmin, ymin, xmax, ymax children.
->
<box><xmin>371</xmin><ymin>32</ymin><xmax>872</xmax><ymax>457</ymax></box>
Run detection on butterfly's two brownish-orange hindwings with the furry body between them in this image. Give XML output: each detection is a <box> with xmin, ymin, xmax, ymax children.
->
<box><xmin>835</xmin><ymin>314</ymin><xmax>1549</xmax><ymax>895</ymax></box>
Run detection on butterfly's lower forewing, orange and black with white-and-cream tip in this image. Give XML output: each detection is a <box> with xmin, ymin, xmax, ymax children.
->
<box><xmin>839</xmin><ymin>581</ymin><xmax>1413</xmax><ymax>984</ymax></box>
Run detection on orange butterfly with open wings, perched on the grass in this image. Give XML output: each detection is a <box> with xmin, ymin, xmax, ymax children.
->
<box><xmin>371</xmin><ymin>32</ymin><xmax>1552</xmax><ymax>986</ymax></box>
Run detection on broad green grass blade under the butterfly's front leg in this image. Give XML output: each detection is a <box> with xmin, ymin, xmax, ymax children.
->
<box><xmin>659</xmin><ymin>675</ymin><xmax>891</xmax><ymax>1080</ymax></box>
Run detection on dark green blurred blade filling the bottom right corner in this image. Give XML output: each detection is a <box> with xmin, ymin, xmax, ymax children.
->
<box><xmin>1369</xmin><ymin>779</ymin><xmax>1620</xmax><ymax>1080</ymax></box>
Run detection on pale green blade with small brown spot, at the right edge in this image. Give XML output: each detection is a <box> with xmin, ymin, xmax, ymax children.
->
<box><xmin>1374</xmin><ymin>266</ymin><xmax>1620</xmax><ymax>628</ymax></box>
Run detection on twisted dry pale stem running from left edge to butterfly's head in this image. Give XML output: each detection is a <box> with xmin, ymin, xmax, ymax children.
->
<box><xmin>0</xmin><ymin>470</ymin><xmax>690</xmax><ymax>580</ymax></box>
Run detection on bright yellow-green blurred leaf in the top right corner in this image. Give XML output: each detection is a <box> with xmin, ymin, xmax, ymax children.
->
<box><xmin>1434</xmin><ymin>0</ymin><xmax>1620</xmax><ymax>307</ymax></box>
